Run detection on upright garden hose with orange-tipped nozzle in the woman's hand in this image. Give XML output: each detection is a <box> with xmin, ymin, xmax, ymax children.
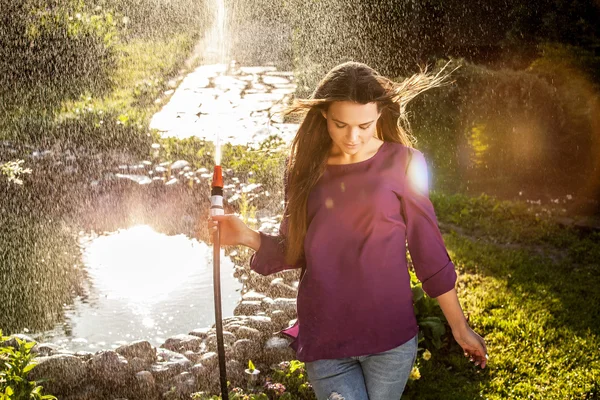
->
<box><xmin>210</xmin><ymin>136</ymin><xmax>229</xmax><ymax>400</ymax></box>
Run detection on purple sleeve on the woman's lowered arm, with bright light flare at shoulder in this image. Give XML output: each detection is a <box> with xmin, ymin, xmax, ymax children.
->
<box><xmin>400</xmin><ymin>148</ymin><xmax>456</xmax><ymax>297</ymax></box>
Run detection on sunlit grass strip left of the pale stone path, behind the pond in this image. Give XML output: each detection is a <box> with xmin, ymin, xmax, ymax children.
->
<box><xmin>0</xmin><ymin>31</ymin><xmax>199</xmax><ymax>153</ymax></box>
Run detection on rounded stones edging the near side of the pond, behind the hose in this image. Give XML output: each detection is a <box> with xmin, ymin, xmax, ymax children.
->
<box><xmin>5</xmin><ymin>266</ymin><xmax>299</xmax><ymax>400</ymax></box>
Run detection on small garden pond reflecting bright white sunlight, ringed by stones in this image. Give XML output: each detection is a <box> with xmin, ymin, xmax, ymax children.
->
<box><xmin>25</xmin><ymin>225</ymin><xmax>242</xmax><ymax>351</ymax></box>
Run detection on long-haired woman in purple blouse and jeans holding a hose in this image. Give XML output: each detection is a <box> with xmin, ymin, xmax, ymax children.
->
<box><xmin>209</xmin><ymin>62</ymin><xmax>487</xmax><ymax>400</ymax></box>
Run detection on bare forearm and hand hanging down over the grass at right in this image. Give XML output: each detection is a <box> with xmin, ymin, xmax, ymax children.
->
<box><xmin>436</xmin><ymin>289</ymin><xmax>488</xmax><ymax>368</ymax></box>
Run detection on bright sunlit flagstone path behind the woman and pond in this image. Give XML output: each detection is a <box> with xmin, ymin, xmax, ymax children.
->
<box><xmin>150</xmin><ymin>61</ymin><xmax>298</xmax><ymax>146</ymax></box>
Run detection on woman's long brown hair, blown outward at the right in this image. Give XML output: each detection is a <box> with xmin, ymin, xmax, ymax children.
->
<box><xmin>283</xmin><ymin>61</ymin><xmax>449</xmax><ymax>265</ymax></box>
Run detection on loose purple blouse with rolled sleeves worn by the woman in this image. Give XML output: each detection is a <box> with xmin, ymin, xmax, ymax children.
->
<box><xmin>250</xmin><ymin>142</ymin><xmax>456</xmax><ymax>362</ymax></box>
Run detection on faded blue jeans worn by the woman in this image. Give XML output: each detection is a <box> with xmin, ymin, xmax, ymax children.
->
<box><xmin>304</xmin><ymin>334</ymin><xmax>418</xmax><ymax>400</ymax></box>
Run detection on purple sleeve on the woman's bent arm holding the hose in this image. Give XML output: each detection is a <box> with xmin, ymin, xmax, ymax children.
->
<box><xmin>250</xmin><ymin>165</ymin><xmax>304</xmax><ymax>275</ymax></box>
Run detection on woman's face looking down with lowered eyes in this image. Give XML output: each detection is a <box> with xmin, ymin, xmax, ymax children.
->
<box><xmin>321</xmin><ymin>101</ymin><xmax>381</xmax><ymax>158</ymax></box>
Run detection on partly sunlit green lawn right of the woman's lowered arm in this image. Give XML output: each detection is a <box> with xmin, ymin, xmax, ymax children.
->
<box><xmin>404</xmin><ymin>193</ymin><xmax>600</xmax><ymax>399</ymax></box>
